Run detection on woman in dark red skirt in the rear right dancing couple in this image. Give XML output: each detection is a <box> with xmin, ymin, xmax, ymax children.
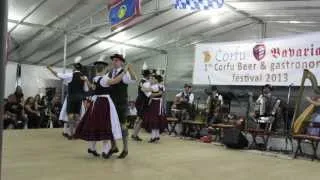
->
<box><xmin>143</xmin><ymin>75</ymin><xmax>167</xmax><ymax>143</ymax></box>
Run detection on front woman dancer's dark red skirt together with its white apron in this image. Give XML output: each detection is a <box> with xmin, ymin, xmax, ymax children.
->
<box><xmin>75</xmin><ymin>95</ymin><xmax>122</xmax><ymax>141</ymax></box>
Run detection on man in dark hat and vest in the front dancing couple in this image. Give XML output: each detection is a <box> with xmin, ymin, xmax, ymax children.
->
<box><xmin>108</xmin><ymin>54</ymin><xmax>137</xmax><ymax>159</ymax></box>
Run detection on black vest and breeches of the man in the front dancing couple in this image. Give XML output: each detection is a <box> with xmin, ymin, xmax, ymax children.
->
<box><xmin>108</xmin><ymin>69</ymin><xmax>128</xmax><ymax>124</ymax></box>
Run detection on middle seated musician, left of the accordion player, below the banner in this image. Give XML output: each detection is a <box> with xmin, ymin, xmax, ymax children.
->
<box><xmin>206</xmin><ymin>86</ymin><xmax>223</xmax><ymax>124</ymax></box>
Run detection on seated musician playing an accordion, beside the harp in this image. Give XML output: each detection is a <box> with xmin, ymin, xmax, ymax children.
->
<box><xmin>251</xmin><ymin>84</ymin><xmax>281</xmax><ymax>129</ymax></box>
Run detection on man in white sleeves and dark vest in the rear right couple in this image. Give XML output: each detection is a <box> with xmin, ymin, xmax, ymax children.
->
<box><xmin>131</xmin><ymin>70</ymin><xmax>152</xmax><ymax>141</ymax></box>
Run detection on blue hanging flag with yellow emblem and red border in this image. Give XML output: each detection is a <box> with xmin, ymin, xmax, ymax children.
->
<box><xmin>109</xmin><ymin>0</ymin><xmax>141</xmax><ymax>31</ymax></box>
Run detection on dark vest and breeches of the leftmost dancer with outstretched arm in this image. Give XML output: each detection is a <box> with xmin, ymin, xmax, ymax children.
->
<box><xmin>67</xmin><ymin>72</ymin><xmax>84</xmax><ymax>114</ymax></box>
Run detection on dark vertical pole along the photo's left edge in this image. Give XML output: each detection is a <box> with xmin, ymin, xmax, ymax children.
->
<box><xmin>0</xmin><ymin>0</ymin><xmax>8</xmax><ymax>180</ymax></box>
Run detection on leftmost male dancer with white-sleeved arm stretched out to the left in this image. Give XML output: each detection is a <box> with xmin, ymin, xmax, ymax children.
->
<box><xmin>47</xmin><ymin>56</ymin><xmax>88</xmax><ymax>139</ymax></box>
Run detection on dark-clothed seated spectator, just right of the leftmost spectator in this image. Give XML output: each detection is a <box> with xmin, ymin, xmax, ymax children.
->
<box><xmin>24</xmin><ymin>97</ymin><xmax>41</xmax><ymax>128</ymax></box>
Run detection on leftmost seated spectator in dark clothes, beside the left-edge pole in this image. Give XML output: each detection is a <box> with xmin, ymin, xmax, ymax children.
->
<box><xmin>4</xmin><ymin>86</ymin><xmax>27</xmax><ymax>129</ymax></box>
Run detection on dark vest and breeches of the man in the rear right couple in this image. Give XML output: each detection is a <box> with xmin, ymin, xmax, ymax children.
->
<box><xmin>135</xmin><ymin>79</ymin><xmax>149</xmax><ymax>118</ymax></box>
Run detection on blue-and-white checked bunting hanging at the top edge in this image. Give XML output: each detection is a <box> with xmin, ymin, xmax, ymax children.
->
<box><xmin>173</xmin><ymin>0</ymin><xmax>224</xmax><ymax>11</ymax></box>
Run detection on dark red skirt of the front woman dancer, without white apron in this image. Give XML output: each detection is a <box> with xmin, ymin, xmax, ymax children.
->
<box><xmin>75</xmin><ymin>97</ymin><xmax>113</xmax><ymax>141</ymax></box>
